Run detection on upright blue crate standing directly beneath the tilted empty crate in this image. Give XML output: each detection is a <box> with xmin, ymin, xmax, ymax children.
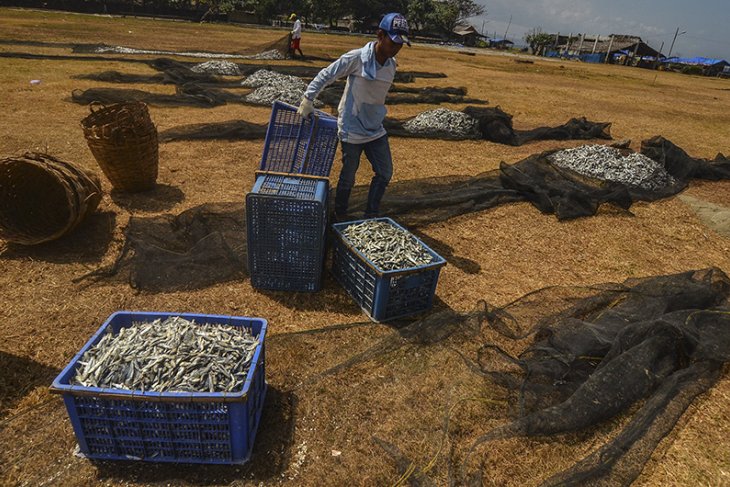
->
<box><xmin>246</xmin><ymin>173</ymin><xmax>329</xmax><ymax>292</ymax></box>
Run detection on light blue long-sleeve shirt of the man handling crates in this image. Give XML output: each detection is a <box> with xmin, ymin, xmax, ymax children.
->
<box><xmin>304</xmin><ymin>41</ymin><xmax>396</xmax><ymax>144</ymax></box>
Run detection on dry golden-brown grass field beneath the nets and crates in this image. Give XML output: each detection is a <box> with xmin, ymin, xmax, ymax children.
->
<box><xmin>0</xmin><ymin>9</ymin><xmax>730</xmax><ymax>486</ymax></box>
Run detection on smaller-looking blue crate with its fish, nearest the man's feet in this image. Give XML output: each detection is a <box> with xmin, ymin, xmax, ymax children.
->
<box><xmin>332</xmin><ymin>218</ymin><xmax>446</xmax><ymax>321</ymax></box>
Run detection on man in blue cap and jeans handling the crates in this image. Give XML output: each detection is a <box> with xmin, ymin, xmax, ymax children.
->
<box><xmin>298</xmin><ymin>13</ymin><xmax>411</xmax><ymax>221</ymax></box>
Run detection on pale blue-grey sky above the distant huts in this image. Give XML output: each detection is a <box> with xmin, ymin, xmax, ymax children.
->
<box><xmin>469</xmin><ymin>0</ymin><xmax>730</xmax><ymax>61</ymax></box>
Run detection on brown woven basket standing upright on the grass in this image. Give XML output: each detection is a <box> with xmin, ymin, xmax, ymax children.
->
<box><xmin>81</xmin><ymin>101</ymin><xmax>159</xmax><ymax>192</ymax></box>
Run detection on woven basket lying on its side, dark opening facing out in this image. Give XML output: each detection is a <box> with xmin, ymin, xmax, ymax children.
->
<box><xmin>0</xmin><ymin>152</ymin><xmax>101</xmax><ymax>245</ymax></box>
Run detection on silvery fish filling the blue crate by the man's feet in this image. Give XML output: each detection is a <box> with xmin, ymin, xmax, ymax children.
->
<box><xmin>342</xmin><ymin>220</ymin><xmax>433</xmax><ymax>271</ymax></box>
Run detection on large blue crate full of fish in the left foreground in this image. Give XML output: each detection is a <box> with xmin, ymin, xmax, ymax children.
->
<box><xmin>51</xmin><ymin>311</ymin><xmax>267</xmax><ymax>464</ymax></box>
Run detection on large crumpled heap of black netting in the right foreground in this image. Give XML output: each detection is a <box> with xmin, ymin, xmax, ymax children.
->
<box><xmin>465</xmin><ymin>269</ymin><xmax>730</xmax><ymax>485</ymax></box>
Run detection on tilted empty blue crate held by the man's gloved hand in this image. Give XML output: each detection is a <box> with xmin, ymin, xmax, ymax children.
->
<box><xmin>260</xmin><ymin>101</ymin><xmax>338</xmax><ymax>177</ymax></box>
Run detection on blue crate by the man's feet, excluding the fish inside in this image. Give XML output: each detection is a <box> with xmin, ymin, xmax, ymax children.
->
<box><xmin>332</xmin><ymin>218</ymin><xmax>446</xmax><ymax>321</ymax></box>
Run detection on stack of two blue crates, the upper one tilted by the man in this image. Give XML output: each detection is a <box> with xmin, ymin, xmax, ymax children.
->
<box><xmin>246</xmin><ymin>101</ymin><xmax>338</xmax><ymax>292</ymax></box>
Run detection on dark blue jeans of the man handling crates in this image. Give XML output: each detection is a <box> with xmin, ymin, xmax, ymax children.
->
<box><xmin>335</xmin><ymin>135</ymin><xmax>393</xmax><ymax>218</ymax></box>
